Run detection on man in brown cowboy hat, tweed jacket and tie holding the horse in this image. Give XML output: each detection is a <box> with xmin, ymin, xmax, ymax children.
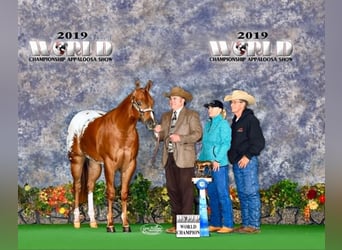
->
<box><xmin>154</xmin><ymin>86</ymin><xmax>202</xmax><ymax>233</ymax></box>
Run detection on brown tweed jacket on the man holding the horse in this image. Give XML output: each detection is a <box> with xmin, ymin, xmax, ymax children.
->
<box><xmin>159</xmin><ymin>107</ymin><xmax>202</xmax><ymax>168</ymax></box>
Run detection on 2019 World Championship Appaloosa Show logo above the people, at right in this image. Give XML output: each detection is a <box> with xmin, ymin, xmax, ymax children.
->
<box><xmin>209</xmin><ymin>32</ymin><xmax>294</xmax><ymax>62</ymax></box>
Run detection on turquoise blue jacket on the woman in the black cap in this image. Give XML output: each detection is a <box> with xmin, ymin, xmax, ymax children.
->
<box><xmin>198</xmin><ymin>115</ymin><xmax>232</xmax><ymax>166</ymax></box>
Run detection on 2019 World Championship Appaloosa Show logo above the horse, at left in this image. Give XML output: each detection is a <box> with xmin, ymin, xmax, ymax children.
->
<box><xmin>29</xmin><ymin>32</ymin><xmax>113</xmax><ymax>62</ymax></box>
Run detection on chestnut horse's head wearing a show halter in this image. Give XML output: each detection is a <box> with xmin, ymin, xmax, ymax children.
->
<box><xmin>132</xmin><ymin>80</ymin><xmax>156</xmax><ymax>130</ymax></box>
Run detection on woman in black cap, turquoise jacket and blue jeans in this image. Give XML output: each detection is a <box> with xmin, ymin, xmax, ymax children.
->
<box><xmin>198</xmin><ymin>100</ymin><xmax>234</xmax><ymax>233</ymax></box>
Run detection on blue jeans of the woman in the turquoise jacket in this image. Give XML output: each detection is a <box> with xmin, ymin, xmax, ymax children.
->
<box><xmin>207</xmin><ymin>166</ymin><xmax>234</xmax><ymax>228</ymax></box>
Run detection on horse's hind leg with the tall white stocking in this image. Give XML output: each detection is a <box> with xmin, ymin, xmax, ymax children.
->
<box><xmin>87</xmin><ymin>160</ymin><xmax>101</xmax><ymax>228</ymax></box>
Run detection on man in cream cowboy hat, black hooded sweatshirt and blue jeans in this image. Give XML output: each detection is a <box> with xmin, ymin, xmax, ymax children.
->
<box><xmin>224</xmin><ymin>90</ymin><xmax>265</xmax><ymax>233</ymax></box>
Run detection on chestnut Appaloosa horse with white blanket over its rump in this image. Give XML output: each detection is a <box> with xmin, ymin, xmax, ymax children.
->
<box><xmin>67</xmin><ymin>80</ymin><xmax>156</xmax><ymax>232</ymax></box>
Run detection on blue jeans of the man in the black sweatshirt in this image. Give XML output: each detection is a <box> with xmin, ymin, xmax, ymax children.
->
<box><xmin>233</xmin><ymin>156</ymin><xmax>261</xmax><ymax>229</ymax></box>
